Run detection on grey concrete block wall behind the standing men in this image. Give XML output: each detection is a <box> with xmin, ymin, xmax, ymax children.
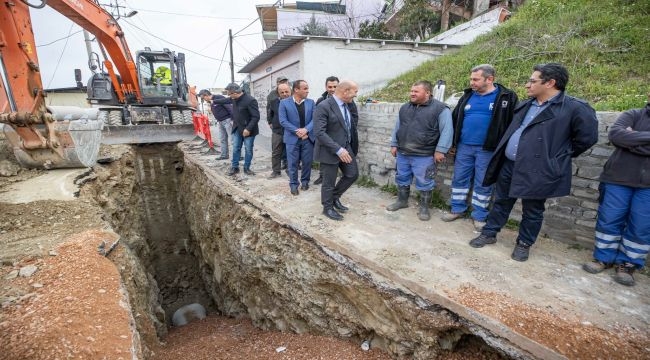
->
<box><xmin>358</xmin><ymin>103</ymin><xmax>619</xmax><ymax>247</ymax></box>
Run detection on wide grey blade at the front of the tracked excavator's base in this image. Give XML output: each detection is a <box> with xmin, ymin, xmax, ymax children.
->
<box><xmin>101</xmin><ymin>124</ymin><xmax>194</xmax><ymax>145</ymax></box>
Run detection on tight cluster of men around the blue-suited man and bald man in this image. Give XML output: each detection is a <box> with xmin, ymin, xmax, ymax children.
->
<box><xmin>267</xmin><ymin>76</ymin><xmax>359</xmax><ymax>220</ymax></box>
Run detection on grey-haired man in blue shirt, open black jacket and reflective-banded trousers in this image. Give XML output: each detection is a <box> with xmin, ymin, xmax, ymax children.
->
<box><xmin>442</xmin><ymin>64</ymin><xmax>517</xmax><ymax>231</ymax></box>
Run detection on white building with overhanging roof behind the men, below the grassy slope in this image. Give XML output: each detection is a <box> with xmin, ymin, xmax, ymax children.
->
<box><xmin>239</xmin><ymin>36</ymin><xmax>457</xmax><ymax>106</ymax></box>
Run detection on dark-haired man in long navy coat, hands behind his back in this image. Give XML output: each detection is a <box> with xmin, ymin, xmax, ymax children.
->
<box><xmin>469</xmin><ymin>63</ymin><xmax>598</xmax><ymax>261</ymax></box>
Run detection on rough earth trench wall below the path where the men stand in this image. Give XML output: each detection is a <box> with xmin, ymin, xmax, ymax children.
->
<box><xmin>180</xmin><ymin>157</ymin><xmax>529</xmax><ymax>359</ymax></box>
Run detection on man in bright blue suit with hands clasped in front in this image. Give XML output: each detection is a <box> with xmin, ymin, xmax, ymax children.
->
<box><xmin>279</xmin><ymin>80</ymin><xmax>315</xmax><ymax>195</ymax></box>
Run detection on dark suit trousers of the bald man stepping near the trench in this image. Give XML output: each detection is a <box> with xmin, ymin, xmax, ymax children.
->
<box><xmin>320</xmin><ymin>156</ymin><xmax>359</xmax><ymax>209</ymax></box>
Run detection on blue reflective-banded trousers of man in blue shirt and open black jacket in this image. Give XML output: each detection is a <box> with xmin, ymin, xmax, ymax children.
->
<box><xmin>451</xmin><ymin>144</ymin><xmax>492</xmax><ymax>221</ymax></box>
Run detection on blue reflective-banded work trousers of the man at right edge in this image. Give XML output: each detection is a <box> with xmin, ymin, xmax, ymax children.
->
<box><xmin>594</xmin><ymin>183</ymin><xmax>650</xmax><ymax>269</ymax></box>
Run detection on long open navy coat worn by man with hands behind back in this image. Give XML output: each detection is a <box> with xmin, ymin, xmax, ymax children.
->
<box><xmin>483</xmin><ymin>92</ymin><xmax>598</xmax><ymax>199</ymax></box>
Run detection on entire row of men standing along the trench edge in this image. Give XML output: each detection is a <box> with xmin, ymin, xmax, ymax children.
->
<box><xmin>200</xmin><ymin>63</ymin><xmax>650</xmax><ymax>285</ymax></box>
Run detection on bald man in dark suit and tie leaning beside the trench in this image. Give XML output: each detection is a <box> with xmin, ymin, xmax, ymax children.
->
<box><xmin>314</xmin><ymin>80</ymin><xmax>359</xmax><ymax>220</ymax></box>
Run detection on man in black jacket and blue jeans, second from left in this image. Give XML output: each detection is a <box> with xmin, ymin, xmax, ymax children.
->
<box><xmin>213</xmin><ymin>83</ymin><xmax>260</xmax><ymax>176</ymax></box>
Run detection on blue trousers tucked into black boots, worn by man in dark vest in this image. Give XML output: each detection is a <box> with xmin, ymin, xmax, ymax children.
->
<box><xmin>395</xmin><ymin>152</ymin><xmax>436</xmax><ymax>191</ymax></box>
